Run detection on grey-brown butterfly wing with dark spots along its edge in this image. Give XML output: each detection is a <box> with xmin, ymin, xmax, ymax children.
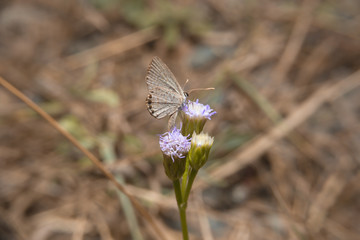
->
<box><xmin>146</xmin><ymin>57</ymin><xmax>186</xmax><ymax>119</ymax></box>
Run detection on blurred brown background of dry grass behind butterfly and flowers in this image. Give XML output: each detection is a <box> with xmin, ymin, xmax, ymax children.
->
<box><xmin>0</xmin><ymin>0</ymin><xmax>360</xmax><ymax>240</ymax></box>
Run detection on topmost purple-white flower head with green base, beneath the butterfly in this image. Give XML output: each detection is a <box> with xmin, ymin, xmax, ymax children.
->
<box><xmin>181</xmin><ymin>99</ymin><xmax>216</xmax><ymax>135</ymax></box>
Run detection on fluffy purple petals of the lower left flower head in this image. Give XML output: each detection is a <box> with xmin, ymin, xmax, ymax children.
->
<box><xmin>159</xmin><ymin>127</ymin><xmax>191</xmax><ymax>162</ymax></box>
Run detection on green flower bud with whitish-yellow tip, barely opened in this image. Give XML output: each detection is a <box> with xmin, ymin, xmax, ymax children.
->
<box><xmin>188</xmin><ymin>132</ymin><xmax>214</xmax><ymax>170</ymax></box>
